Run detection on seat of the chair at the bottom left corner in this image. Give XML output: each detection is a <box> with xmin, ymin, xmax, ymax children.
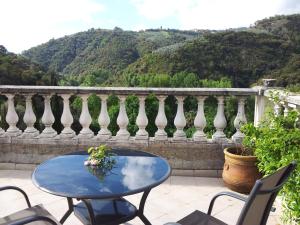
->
<box><xmin>0</xmin><ymin>205</ymin><xmax>60</xmax><ymax>225</ymax></box>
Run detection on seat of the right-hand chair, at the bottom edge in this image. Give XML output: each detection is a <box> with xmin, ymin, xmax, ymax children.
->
<box><xmin>177</xmin><ymin>210</ymin><xmax>227</xmax><ymax>225</ymax></box>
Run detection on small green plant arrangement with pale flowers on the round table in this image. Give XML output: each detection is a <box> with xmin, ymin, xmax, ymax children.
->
<box><xmin>85</xmin><ymin>145</ymin><xmax>115</xmax><ymax>169</ymax></box>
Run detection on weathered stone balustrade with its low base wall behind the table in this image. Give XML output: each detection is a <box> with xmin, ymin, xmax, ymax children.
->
<box><xmin>0</xmin><ymin>85</ymin><xmax>300</xmax><ymax>173</ymax></box>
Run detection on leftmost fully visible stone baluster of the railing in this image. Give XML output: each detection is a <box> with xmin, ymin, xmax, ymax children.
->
<box><xmin>5</xmin><ymin>94</ymin><xmax>22</xmax><ymax>137</ymax></box>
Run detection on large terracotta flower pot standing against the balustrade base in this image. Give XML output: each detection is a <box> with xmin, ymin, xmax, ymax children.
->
<box><xmin>222</xmin><ymin>147</ymin><xmax>262</xmax><ymax>194</ymax></box>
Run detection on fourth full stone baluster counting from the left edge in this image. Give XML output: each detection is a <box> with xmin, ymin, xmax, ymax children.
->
<box><xmin>60</xmin><ymin>94</ymin><xmax>76</xmax><ymax>138</ymax></box>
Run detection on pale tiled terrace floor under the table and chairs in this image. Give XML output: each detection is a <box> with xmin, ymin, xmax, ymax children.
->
<box><xmin>0</xmin><ymin>170</ymin><xmax>281</xmax><ymax>225</ymax></box>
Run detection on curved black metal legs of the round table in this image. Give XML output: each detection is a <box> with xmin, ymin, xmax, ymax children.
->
<box><xmin>60</xmin><ymin>188</ymin><xmax>152</xmax><ymax>225</ymax></box>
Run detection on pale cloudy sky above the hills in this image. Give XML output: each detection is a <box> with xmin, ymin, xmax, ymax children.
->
<box><xmin>0</xmin><ymin>0</ymin><xmax>300</xmax><ymax>53</ymax></box>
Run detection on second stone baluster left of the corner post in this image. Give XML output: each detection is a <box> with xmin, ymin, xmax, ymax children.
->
<box><xmin>212</xmin><ymin>96</ymin><xmax>226</xmax><ymax>142</ymax></box>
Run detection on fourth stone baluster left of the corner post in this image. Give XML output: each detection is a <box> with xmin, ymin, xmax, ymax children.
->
<box><xmin>173</xmin><ymin>96</ymin><xmax>186</xmax><ymax>141</ymax></box>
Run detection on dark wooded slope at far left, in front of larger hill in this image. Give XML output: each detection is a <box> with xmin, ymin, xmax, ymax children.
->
<box><xmin>0</xmin><ymin>45</ymin><xmax>57</xmax><ymax>85</ymax></box>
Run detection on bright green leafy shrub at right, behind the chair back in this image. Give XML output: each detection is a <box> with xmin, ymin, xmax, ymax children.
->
<box><xmin>242</xmin><ymin>111</ymin><xmax>300</xmax><ymax>224</ymax></box>
